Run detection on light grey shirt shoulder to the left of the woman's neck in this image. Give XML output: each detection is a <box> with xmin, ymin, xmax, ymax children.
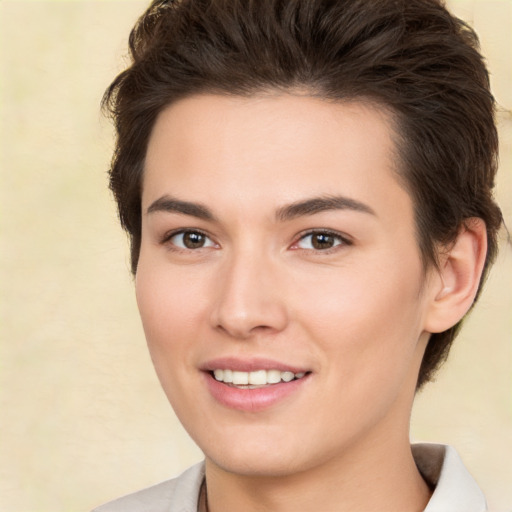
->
<box><xmin>92</xmin><ymin>463</ymin><xmax>204</xmax><ymax>512</ymax></box>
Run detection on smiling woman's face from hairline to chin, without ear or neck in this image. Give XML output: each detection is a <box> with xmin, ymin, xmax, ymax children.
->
<box><xmin>136</xmin><ymin>95</ymin><xmax>436</xmax><ymax>475</ymax></box>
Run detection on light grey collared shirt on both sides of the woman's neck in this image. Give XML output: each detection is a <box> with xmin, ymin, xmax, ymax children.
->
<box><xmin>92</xmin><ymin>444</ymin><xmax>487</xmax><ymax>512</ymax></box>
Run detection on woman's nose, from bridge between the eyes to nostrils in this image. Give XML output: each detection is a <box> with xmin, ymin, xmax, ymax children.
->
<box><xmin>211</xmin><ymin>250</ymin><xmax>288</xmax><ymax>339</ymax></box>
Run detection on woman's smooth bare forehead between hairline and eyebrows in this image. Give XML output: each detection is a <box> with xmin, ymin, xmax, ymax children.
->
<box><xmin>143</xmin><ymin>94</ymin><xmax>410</xmax><ymax>223</ymax></box>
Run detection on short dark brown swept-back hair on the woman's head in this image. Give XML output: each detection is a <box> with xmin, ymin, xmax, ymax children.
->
<box><xmin>103</xmin><ymin>0</ymin><xmax>502</xmax><ymax>389</ymax></box>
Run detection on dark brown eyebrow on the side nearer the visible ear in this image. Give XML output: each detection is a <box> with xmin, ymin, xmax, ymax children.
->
<box><xmin>276</xmin><ymin>196</ymin><xmax>377</xmax><ymax>222</ymax></box>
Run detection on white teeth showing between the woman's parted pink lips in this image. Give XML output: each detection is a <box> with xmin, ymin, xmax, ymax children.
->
<box><xmin>209</xmin><ymin>368</ymin><xmax>311</xmax><ymax>389</ymax></box>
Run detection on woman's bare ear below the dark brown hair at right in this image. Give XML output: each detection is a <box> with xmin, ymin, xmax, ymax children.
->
<box><xmin>424</xmin><ymin>217</ymin><xmax>487</xmax><ymax>333</ymax></box>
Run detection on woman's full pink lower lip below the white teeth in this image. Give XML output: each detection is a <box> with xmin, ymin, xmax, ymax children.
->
<box><xmin>204</xmin><ymin>372</ymin><xmax>310</xmax><ymax>412</ymax></box>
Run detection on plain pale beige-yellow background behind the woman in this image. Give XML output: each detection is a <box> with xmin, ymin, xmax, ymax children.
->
<box><xmin>0</xmin><ymin>0</ymin><xmax>512</xmax><ymax>512</ymax></box>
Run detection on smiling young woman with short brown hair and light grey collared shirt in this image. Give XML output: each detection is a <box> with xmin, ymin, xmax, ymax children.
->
<box><xmin>96</xmin><ymin>0</ymin><xmax>501</xmax><ymax>512</ymax></box>
